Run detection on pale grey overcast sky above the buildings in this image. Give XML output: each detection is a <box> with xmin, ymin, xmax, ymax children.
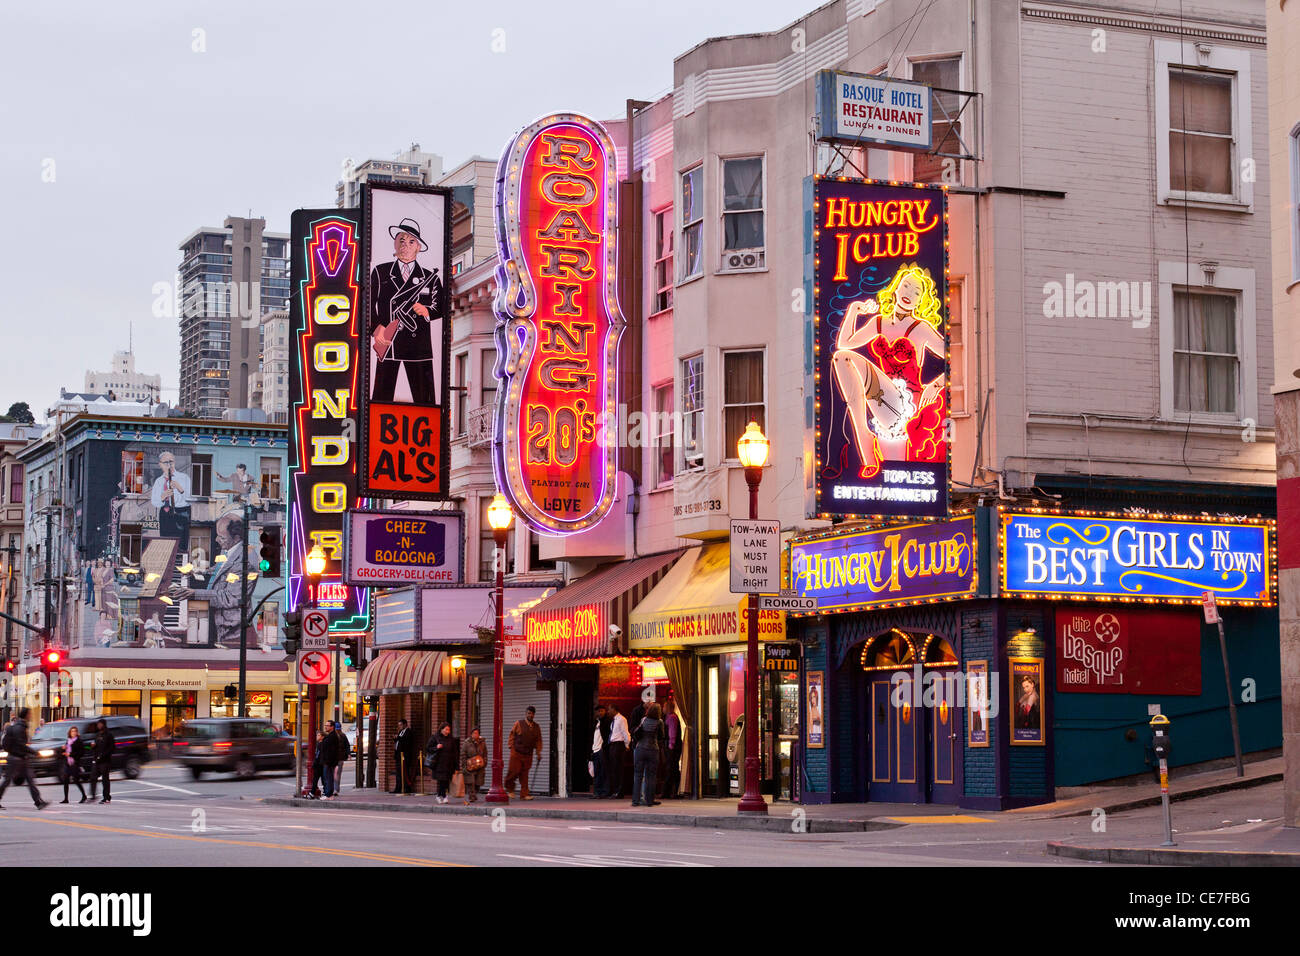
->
<box><xmin>0</xmin><ymin>0</ymin><xmax>818</xmax><ymax>420</ymax></box>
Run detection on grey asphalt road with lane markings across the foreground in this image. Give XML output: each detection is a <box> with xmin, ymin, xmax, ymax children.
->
<box><xmin>0</xmin><ymin>763</ymin><xmax>1279</xmax><ymax>868</ymax></box>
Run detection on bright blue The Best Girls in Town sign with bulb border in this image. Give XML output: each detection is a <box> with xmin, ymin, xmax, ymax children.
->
<box><xmin>1000</xmin><ymin>512</ymin><xmax>1275</xmax><ymax>605</ymax></box>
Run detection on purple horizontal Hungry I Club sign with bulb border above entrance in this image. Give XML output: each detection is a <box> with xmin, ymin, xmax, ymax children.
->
<box><xmin>790</xmin><ymin>515</ymin><xmax>976</xmax><ymax>614</ymax></box>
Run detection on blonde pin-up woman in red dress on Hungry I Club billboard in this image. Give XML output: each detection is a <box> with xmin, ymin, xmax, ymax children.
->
<box><xmin>831</xmin><ymin>265</ymin><xmax>946</xmax><ymax>479</ymax></box>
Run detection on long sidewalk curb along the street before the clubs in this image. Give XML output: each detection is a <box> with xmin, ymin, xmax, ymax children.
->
<box><xmin>257</xmin><ymin>797</ymin><xmax>907</xmax><ymax>834</ymax></box>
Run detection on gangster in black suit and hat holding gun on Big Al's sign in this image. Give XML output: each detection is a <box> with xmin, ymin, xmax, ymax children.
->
<box><xmin>371</xmin><ymin>217</ymin><xmax>442</xmax><ymax>405</ymax></box>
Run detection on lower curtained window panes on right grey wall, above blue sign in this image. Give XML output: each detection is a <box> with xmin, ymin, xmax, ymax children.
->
<box><xmin>1174</xmin><ymin>291</ymin><xmax>1240</xmax><ymax>416</ymax></box>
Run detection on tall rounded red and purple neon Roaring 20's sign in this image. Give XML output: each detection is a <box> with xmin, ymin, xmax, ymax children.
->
<box><xmin>493</xmin><ymin>113</ymin><xmax>624</xmax><ymax>535</ymax></box>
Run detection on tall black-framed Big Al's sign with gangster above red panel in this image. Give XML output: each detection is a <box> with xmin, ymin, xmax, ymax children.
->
<box><xmin>358</xmin><ymin>183</ymin><xmax>451</xmax><ymax>501</ymax></box>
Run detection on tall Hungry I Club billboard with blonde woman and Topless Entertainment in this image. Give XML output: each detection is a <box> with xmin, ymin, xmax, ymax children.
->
<box><xmin>813</xmin><ymin>177</ymin><xmax>949</xmax><ymax>518</ymax></box>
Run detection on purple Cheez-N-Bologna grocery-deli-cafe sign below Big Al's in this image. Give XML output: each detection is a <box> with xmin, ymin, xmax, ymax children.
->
<box><xmin>343</xmin><ymin>509</ymin><xmax>464</xmax><ymax>588</ymax></box>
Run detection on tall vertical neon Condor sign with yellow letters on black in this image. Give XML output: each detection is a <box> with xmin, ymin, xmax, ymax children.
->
<box><xmin>289</xmin><ymin>209</ymin><xmax>369</xmax><ymax>631</ymax></box>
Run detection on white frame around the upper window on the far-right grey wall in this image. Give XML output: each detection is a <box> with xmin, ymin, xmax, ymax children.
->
<box><xmin>1154</xmin><ymin>39</ymin><xmax>1255</xmax><ymax>212</ymax></box>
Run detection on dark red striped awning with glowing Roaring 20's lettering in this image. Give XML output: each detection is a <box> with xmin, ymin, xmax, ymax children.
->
<box><xmin>524</xmin><ymin>550</ymin><xmax>681</xmax><ymax>663</ymax></box>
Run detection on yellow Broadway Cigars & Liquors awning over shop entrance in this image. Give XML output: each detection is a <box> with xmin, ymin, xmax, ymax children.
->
<box><xmin>628</xmin><ymin>541</ymin><xmax>785</xmax><ymax>653</ymax></box>
